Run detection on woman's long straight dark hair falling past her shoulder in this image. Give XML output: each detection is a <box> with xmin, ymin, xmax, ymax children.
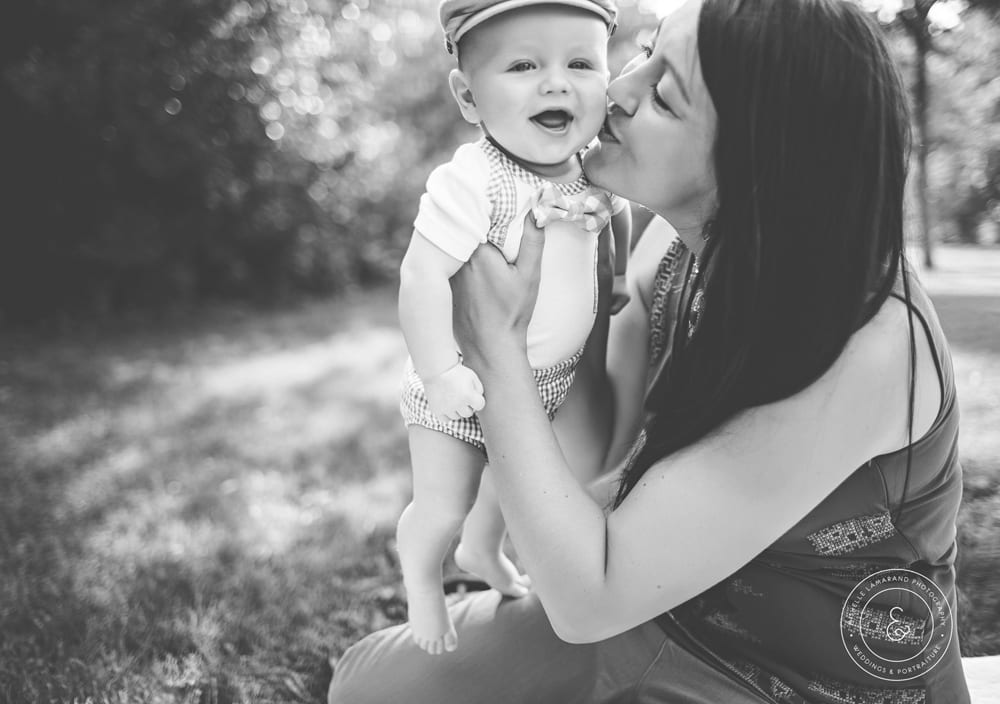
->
<box><xmin>615</xmin><ymin>0</ymin><xmax>912</xmax><ymax>505</ymax></box>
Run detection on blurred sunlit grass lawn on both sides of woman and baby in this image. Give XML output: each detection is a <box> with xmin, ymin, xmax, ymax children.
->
<box><xmin>0</xmin><ymin>248</ymin><xmax>1000</xmax><ymax>704</ymax></box>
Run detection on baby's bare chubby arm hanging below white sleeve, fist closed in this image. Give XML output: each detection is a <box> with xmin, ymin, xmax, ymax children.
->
<box><xmin>399</xmin><ymin>230</ymin><xmax>485</xmax><ymax>420</ymax></box>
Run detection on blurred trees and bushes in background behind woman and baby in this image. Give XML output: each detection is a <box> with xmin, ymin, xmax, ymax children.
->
<box><xmin>0</xmin><ymin>0</ymin><xmax>1000</xmax><ymax>322</ymax></box>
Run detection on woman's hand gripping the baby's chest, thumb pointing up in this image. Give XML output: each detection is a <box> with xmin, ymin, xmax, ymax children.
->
<box><xmin>451</xmin><ymin>214</ymin><xmax>545</xmax><ymax>369</ymax></box>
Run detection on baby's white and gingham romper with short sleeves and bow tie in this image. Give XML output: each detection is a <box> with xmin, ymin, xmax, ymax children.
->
<box><xmin>400</xmin><ymin>138</ymin><xmax>625</xmax><ymax>454</ymax></box>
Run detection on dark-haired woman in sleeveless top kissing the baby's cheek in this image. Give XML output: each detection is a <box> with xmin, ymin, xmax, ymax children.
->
<box><xmin>330</xmin><ymin>0</ymin><xmax>968</xmax><ymax>703</ymax></box>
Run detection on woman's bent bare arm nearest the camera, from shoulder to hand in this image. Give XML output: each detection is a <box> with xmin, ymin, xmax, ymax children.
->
<box><xmin>456</xmin><ymin>230</ymin><xmax>940</xmax><ymax>642</ymax></box>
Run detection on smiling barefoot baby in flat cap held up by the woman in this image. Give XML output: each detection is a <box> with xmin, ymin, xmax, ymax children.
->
<box><xmin>397</xmin><ymin>0</ymin><xmax>630</xmax><ymax>654</ymax></box>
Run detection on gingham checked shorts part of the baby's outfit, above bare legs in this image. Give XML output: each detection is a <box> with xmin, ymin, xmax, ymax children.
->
<box><xmin>399</xmin><ymin>348</ymin><xmax>583</xmax><ymax>455</ymax></box>
